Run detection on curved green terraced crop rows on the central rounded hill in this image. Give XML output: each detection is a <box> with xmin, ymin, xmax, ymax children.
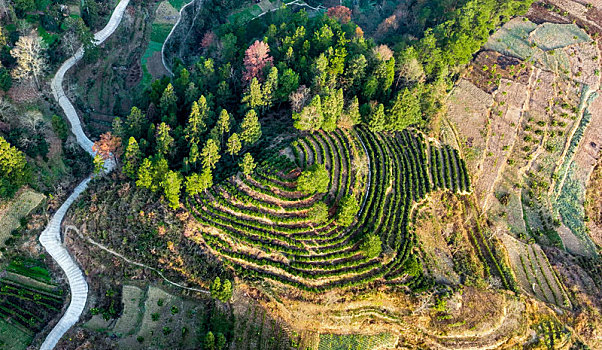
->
<box><xmin>187</xmin><ymin>128</ymin><xmax>470</xmax><ymax>292</ymax></box>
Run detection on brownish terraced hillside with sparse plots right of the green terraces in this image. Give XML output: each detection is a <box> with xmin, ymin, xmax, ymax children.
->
<box><xmin>442</xmin><ymin>4</ymin><xmax>602</xmax><ymax>314</ymax></box>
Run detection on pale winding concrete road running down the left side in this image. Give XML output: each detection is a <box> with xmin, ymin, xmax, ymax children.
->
<box><xmin>40</xmin><ymin>0</ymin><xmax>130</xmax><ymax>350</ymax></box>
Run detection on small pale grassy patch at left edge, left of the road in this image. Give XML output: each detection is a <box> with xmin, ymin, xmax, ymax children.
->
<box><xmin>0</xmin><ymin>190</ymin><xmax>46</xmax><ymax>246</ymax></box>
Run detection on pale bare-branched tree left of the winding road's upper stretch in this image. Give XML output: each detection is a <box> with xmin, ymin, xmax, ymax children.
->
<box><xmin>10</xmin><ymin>32</ymin><xmax>48</xmax><ymax>88</ymax></box>
